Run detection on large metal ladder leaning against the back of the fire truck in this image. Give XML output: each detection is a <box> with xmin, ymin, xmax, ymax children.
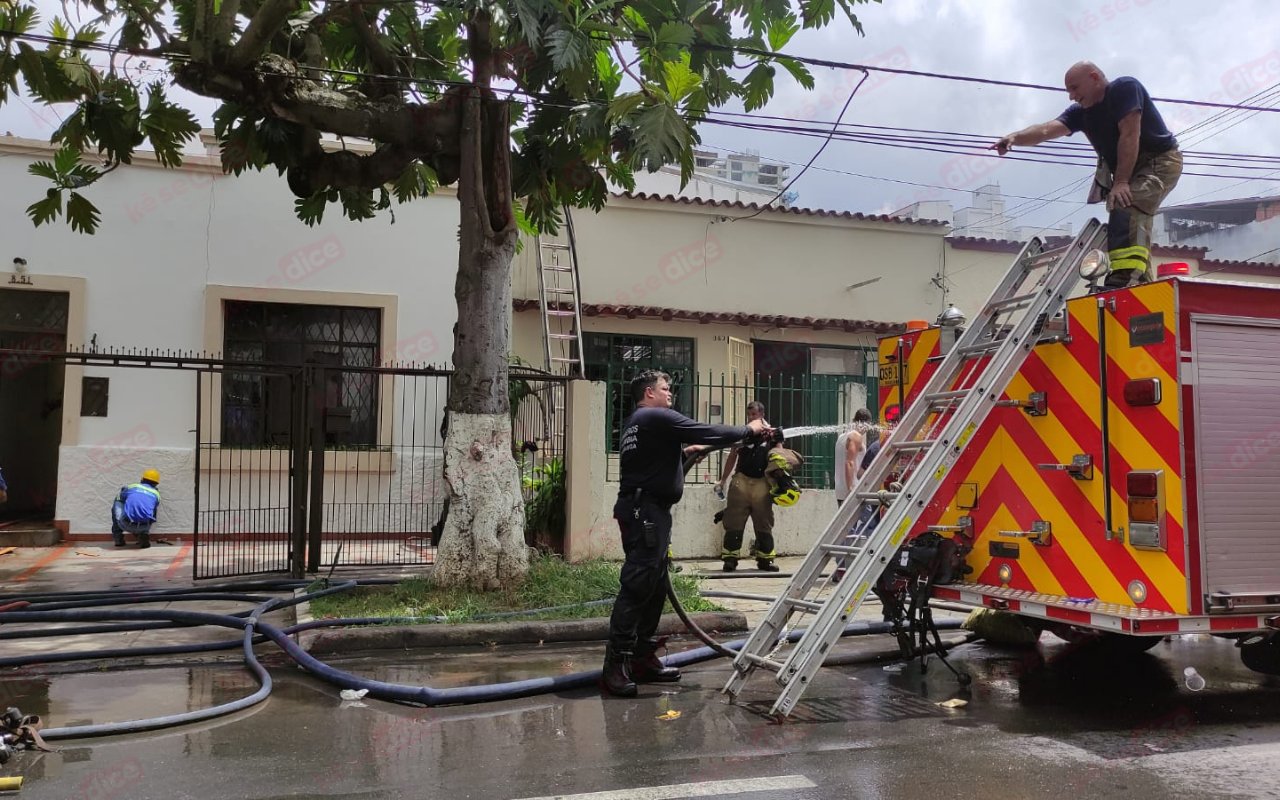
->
<box><xmin>724</xmin><ymin>213</ymin><xmax>1106</xmax><ymax>717</ymax></box>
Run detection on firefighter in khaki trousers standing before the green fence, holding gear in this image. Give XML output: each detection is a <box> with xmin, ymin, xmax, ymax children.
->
<box><xmin>721</xmin><ymin>401</ymin><xmax>778</xmax><ymax>572</ymax></box>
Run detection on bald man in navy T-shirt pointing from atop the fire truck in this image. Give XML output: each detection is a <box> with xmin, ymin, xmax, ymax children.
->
<box><xmin>992</xmin><ymin>61</ymin><xmax>1183</xmax><ymax>288</ymax></box>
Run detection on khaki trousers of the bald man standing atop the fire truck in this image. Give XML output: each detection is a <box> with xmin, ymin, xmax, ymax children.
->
<box><xmin>1089</xmin><ymin>147</ymin><xmax>1183</xmax><ymax>288</ymax></box>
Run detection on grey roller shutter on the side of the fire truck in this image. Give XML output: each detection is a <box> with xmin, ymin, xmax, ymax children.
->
<box><xmin>1192</xmin><ymin>323</ymin><xmax>1280</xmax><ymax>594</ymax></box>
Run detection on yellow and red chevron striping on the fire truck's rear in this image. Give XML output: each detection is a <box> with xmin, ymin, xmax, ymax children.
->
<box><xmin>896</xmin><ymin>282</ymin><xmax>1182</xmax><ymax>614</ymax></box>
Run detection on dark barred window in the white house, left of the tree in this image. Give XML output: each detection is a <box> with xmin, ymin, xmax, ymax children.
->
<box><xmin>223</xmin><ymin>301</ymin><xmax>381</xmax><ymax>447</ymax></box>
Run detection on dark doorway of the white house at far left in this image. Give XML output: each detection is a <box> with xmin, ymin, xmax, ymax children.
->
<box><xmin>0</xmin><ymin>289</ymin><xmax>68</xmax><ymax>522</ymax></box>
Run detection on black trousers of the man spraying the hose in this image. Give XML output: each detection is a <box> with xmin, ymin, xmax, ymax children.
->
<box><xmin>609</xmin><ymin>499</ymin><xmax>671</xmax><ymax>653</ymax></box>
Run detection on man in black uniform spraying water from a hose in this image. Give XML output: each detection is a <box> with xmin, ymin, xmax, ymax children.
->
<box><xmin>600</xmin><ymin>370</ymin><xmax>768</xmax><ymax>698</ymax></box>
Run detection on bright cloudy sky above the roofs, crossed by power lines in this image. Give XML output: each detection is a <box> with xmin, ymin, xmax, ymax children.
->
<box><xmin>0</xmin><ymin>0</ymin><xmax>1280</xmax><ymax>243</ymax></box>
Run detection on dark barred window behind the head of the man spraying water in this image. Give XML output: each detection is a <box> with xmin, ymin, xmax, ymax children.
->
<box><xmin>582</xmin><ymin>333</ymin><xmax>694</xmax><ymax>452</ymax></box>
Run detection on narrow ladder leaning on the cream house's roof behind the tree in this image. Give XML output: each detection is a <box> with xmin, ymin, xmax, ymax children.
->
<box><xmin>536</xmin><ymin>209</ymin><xmax>586</xmax><ymax>378</ymax></box>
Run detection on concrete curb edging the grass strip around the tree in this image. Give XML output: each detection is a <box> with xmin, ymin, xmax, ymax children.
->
<box><xmin>298</xmin><ymin>608</ymin><xmax>748</xmax><ymax>655</ymax></box>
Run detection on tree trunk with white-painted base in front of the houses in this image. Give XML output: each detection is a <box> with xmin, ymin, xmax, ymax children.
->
<box><xmin>435</xmin><ymin>71</ymin><xmax>529</xmax><ymax>589</ymax></box>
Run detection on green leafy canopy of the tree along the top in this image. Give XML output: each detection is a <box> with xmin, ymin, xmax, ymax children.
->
<box><xmin>0</xmin><ymin>0</ymin><xmax>864</xmax><ymax>233</ymax></box>
